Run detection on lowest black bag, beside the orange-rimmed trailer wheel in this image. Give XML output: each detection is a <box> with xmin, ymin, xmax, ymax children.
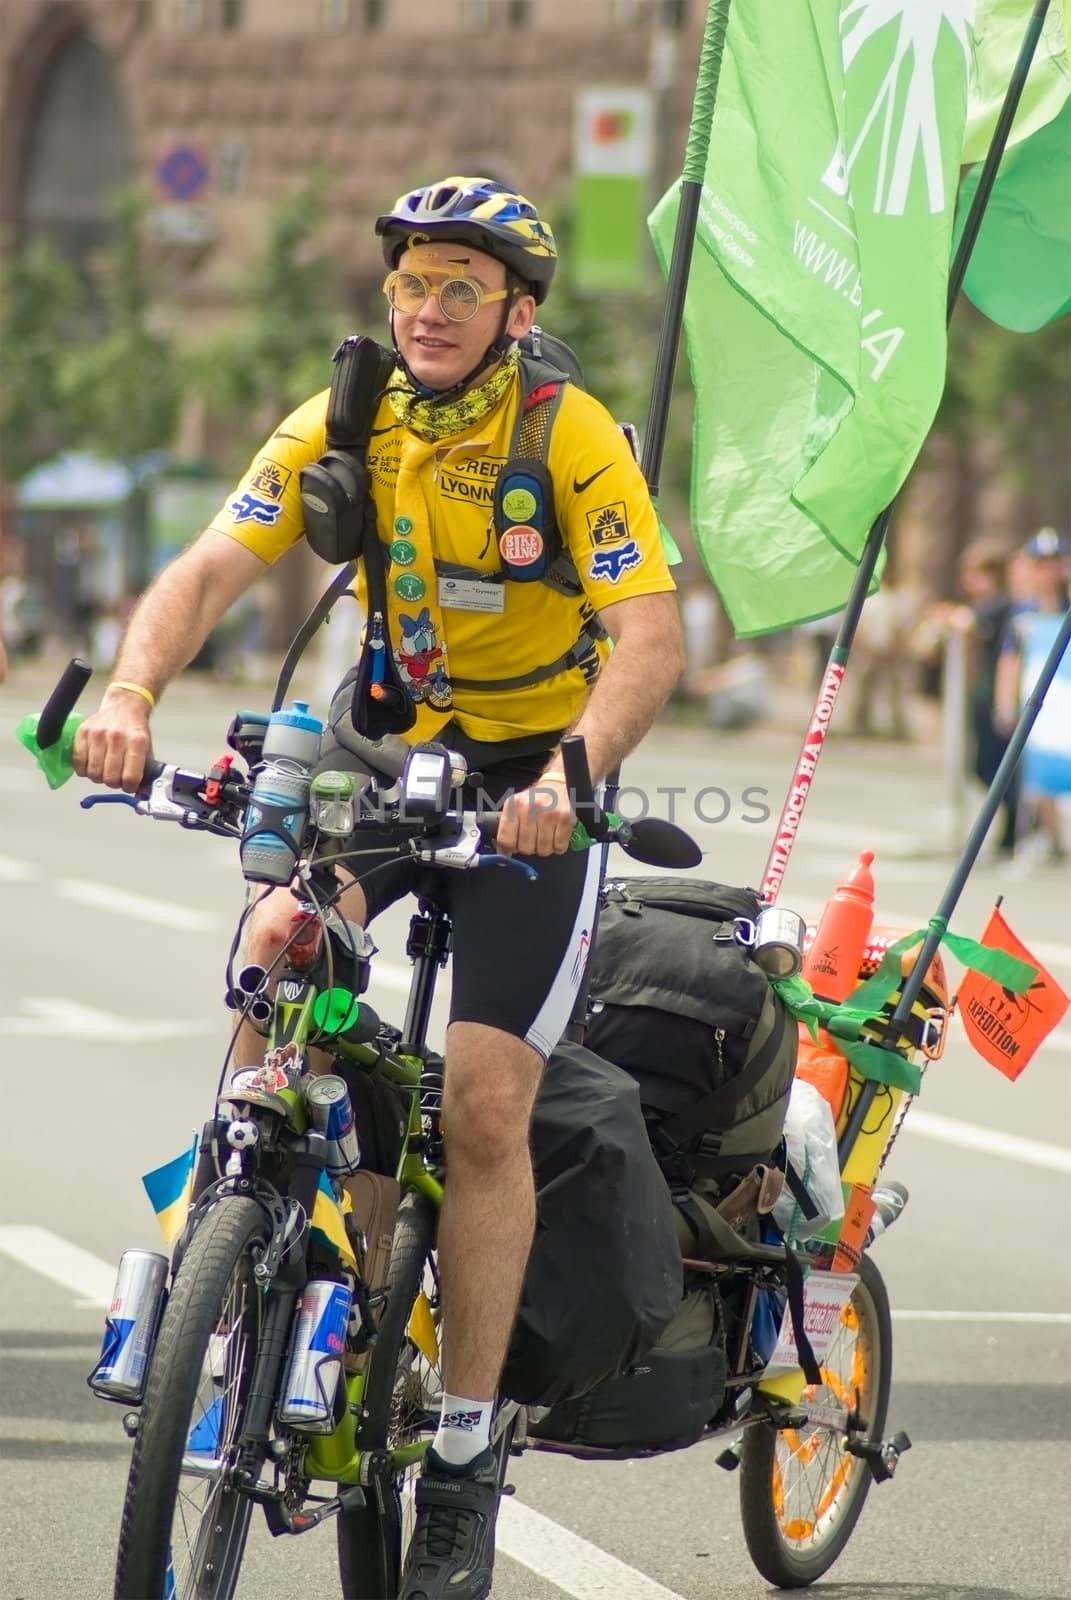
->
<box><xmin>528</xmin><ymin>1280</ymin><xmax>725</xmax><ymax>1456</ymax></box>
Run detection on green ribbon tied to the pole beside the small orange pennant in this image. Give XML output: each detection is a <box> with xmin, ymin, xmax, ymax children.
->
<box><xmin>772</xmin><ymin>917</ymin><xmax>1037</xmax><ymax>1094</ymax></box>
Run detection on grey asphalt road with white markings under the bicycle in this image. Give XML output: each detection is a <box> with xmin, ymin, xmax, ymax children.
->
<box><xmin>0</xmin><ymin>656</ymin><xmax>1071</xmax><ymax>1600</ymax></box>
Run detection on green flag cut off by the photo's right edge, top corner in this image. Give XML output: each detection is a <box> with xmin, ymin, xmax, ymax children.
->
<box><xmin>959</xmin><ymin>0</ymin><xmax>1071</xmax><ymax>333</ymax></box>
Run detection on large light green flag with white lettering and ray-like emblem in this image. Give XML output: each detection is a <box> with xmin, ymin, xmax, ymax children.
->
<box><xmin>652</xmin><ymin>0</ymin><xmax>973</xmax><ymax>635</ymax></box>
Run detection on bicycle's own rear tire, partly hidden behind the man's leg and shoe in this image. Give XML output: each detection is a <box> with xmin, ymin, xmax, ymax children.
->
<box><xmin>338</xmin><ymin>1194</ymin><xmax>437</xmax><ymax>1600</ymax></box>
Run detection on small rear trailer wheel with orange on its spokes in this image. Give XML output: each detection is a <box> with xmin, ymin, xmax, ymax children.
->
<box><xmin>740</xmin><ymin>1256</ymin><xmax>892</xmax><ymax>1589</ymax></box>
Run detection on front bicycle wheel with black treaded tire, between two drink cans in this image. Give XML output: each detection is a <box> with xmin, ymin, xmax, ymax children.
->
<box><xmin>115</xmin><ymin>1198</ymin><xmax>269</xmax><ymax>1600</ymax></box>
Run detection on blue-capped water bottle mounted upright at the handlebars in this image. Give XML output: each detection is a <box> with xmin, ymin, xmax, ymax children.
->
<box><xmin>242</xmin><ymin>701</ymin><xmax>323</xmax><ymax>883</ymax></box>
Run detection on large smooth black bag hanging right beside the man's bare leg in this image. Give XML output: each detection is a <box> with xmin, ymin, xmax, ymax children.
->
<box><xmin>499</xmin><ymin>1043</ymin><xmax>684</xmax><ymax>1405</ymax></box>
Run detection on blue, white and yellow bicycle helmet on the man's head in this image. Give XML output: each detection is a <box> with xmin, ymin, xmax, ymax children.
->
<box><xmin>376</xmin><ymin>178</ymin><xmax>557</xmax><ymax>306</ymax></box>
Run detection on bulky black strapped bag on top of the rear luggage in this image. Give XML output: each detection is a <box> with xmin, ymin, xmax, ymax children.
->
<box><xmin>586</xmin><ymin>877</ymin><xmax>799</xmax><ymax>1189</ymax></box>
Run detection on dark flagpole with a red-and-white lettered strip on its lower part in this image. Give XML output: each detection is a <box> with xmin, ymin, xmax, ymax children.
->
<box><xmin>759</xmin><ymin>0</ymin><xmax>1050</xmax><ymax>908</ymax></box>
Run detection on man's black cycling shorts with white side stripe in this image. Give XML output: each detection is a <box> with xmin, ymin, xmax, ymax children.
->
<box><xmin>317</xmin><ymin>680</ymin><xmax>599</xmax><ymax>1058</ymax></box>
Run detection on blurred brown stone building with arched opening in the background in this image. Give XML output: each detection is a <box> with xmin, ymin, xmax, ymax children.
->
<box><xmin>0</xmin><ymin>0</ymin><xmax>706</xmax><ymax>312</ymax></box>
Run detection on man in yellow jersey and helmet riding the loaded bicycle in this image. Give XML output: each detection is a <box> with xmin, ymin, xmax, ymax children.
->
<box><xmin>75</xmin><ymin>178</ymin><xmax>684</xmax><ymax>1600</ymax></box>
